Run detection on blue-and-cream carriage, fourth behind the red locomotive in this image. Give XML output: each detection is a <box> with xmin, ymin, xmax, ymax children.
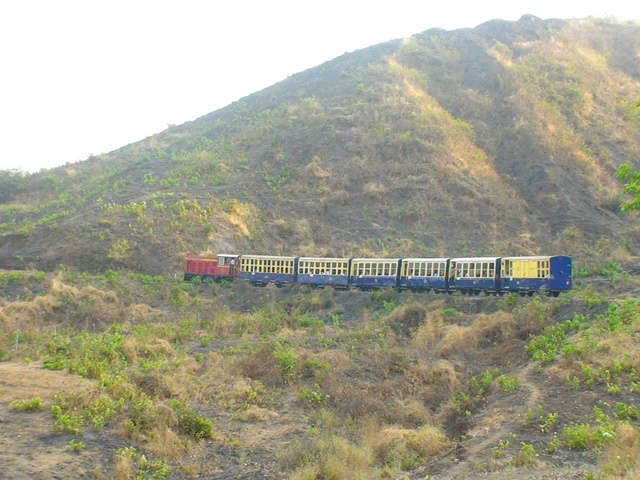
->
<box><xmin>399</xmin><ymin>258</ymin><xmax>449</xmax><ymax>292</ymax></box>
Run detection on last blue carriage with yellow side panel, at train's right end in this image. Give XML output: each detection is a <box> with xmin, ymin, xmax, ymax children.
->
<box><xmin>500</xmin><ymin>255</ymin><xmax>572</xmax><ymax>297</ymax></box>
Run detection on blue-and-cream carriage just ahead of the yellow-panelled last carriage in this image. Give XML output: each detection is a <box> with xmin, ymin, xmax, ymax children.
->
<box><xmin>449</xmin><ymin>257</ymin><xmax>500</xmax><ymax>295</ymax></box>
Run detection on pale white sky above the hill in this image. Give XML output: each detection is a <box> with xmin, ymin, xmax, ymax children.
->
<box><xmin>0</xmin><ymin>0</ymin><xmax>640</xmax><ymax>172</ymax></box>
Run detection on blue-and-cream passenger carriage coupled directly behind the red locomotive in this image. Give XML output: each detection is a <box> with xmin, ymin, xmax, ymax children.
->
<box><xmin>239</xmin><ymin>255</ymin><xmax>298</xmax><ymax>287</ymax></box>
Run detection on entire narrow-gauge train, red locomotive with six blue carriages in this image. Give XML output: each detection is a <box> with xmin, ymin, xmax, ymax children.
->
<box><xmin>184</xmin><ymin>253</ymin><xmax>573</xmax><ymax>297</ymax></box>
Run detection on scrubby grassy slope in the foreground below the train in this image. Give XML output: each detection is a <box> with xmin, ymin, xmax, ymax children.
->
<box><xmin>0</xmin><ymin>250</ymin><xmax>640</xmax><ymax>479</ymax></box>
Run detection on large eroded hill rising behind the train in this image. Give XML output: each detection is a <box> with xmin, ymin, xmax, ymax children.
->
<box><xmin>0</xmin><ymin>16</ymin><xmax>640</xmax><ymax>274</ymax></box>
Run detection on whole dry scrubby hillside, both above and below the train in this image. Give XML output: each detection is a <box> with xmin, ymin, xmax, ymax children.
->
<box><xmin>0</xmin><ymin>16</ymin><xmax>640</xmax><ymax>480</ymax></box>
